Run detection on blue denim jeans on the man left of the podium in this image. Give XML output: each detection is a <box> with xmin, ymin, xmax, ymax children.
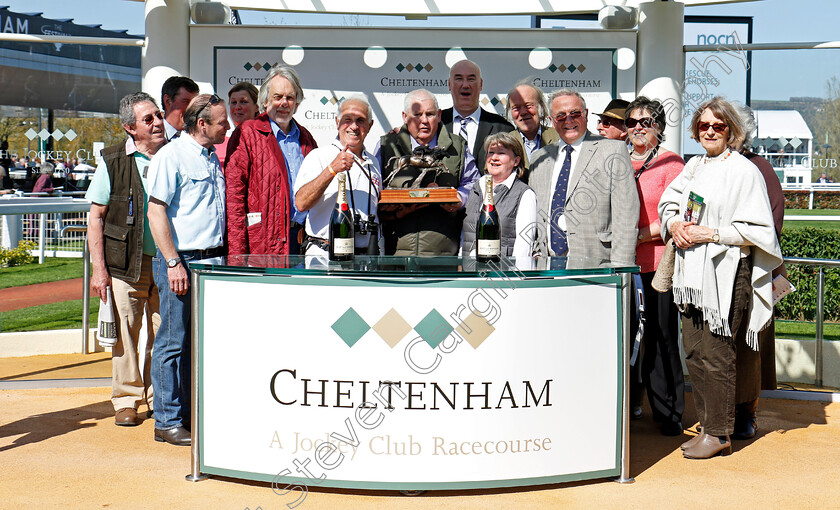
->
<box><xmin>152</xmin><ymin>250</ymin><xmax>195</xmax><ymax>430</ymax></box>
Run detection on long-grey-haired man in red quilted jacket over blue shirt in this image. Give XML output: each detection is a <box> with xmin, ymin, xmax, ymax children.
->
<box><xmin>225</xmin><ymin>66</ymin><xmax>318</xmax><ymax>255</ymax></box>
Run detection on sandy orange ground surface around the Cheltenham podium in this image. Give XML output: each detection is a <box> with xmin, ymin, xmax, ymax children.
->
<box><xmin>0</xmin><ymin>353</ymin><xmax>840</xmax><ymax>510</ymax></box>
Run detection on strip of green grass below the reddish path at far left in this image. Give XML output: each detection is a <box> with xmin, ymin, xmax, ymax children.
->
<box><xmin>0</xmin><ymin>297</ymin><xmax>99</xmax><ymax>333</ymax></box>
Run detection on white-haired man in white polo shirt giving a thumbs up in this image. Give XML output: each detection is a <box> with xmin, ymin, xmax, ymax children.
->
<box><xmin>294</xmin><ymin>94</ymin><xmax>382</xmax><ymax>255</ymax></box>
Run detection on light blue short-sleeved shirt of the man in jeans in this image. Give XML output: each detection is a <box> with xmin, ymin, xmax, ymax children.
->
<box><xmin>149</xmin><ymin>132</ymin><xmax>225</xmax><ymax>251</ymax></box>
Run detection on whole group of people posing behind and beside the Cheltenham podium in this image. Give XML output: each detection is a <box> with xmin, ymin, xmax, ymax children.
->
<box><xmin>88</xmin><ymin>60</ymin><xmax>783</xmax><ymax>458</ymax></box>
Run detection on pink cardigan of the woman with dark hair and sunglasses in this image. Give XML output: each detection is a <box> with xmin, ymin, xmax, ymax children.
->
<box><xmin>633</xmin><ymin>149</ymin><xmax>685</xmax><ymax>273</ymax></box>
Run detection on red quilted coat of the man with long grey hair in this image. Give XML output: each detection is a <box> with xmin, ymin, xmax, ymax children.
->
<box><xmin>225</xmin><ymin>113</ymin><xmax>318</xmax><ymax>255</ymax></box>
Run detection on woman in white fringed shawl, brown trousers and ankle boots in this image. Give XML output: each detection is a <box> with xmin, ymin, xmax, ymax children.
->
<box><xmin>659</xmin><ymin>97</ymin><xmax>782</xmax><ymax>459</ymax></box>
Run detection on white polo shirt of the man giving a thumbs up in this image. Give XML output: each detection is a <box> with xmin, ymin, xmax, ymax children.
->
<box><xmin>294</xmin><ymin>141</ymin><xmax>378</xmax><ymax>255</ymax></box>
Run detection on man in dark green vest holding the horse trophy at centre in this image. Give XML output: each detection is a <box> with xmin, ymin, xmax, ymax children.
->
<box><xmin>378</xmin><ymin>89</ymin><xmax>478</xmax><ymax>256</ymax></box>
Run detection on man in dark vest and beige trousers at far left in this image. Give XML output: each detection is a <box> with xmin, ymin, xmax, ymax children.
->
<box><xmin>86</xmin><ymin>92</ymin><xmax>166</xmax><ymax>426</ymax></box>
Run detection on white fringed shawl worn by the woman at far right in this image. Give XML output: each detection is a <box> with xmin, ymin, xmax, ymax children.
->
<box><xmin>659</xmin><ymin>152</ymin><xmax>782</xmax><ymax>350</ymax></box>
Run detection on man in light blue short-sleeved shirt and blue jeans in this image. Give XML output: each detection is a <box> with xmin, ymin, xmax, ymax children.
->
<box><xmin>148</xmin><ymin>94</ymin><xmax>229</xmax><ymax>445</ymax></box>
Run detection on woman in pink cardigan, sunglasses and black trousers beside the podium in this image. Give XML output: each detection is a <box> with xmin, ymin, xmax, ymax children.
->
<box><xmin>624</xmin><ymin>96</ymin><xmax>685</xmax><ymax>436</ymax></box>
